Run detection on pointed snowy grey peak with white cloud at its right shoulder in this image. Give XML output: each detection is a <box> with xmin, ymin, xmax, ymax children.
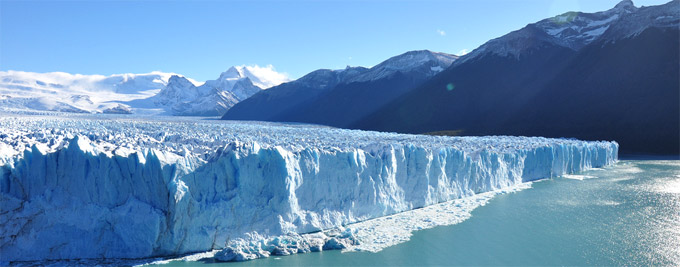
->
<box><xmin>153</xmin><ymin>66</ymin><xmax>288</xmax><ymax>116</ymax></box>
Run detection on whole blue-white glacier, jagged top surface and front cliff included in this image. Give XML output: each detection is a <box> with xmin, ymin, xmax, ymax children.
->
<box><xmin>0</xmin><ymin>115</ymin><xmax>618</xmax><ymax>262</ymax></box>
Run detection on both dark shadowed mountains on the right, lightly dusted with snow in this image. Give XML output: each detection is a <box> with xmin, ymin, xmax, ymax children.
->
<box><xmin>223</xmin><ymin>0</ymin><xmax>680</xmax><ymax>154</ymax></box>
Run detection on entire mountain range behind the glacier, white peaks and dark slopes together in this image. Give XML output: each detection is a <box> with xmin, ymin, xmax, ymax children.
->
<box><xmin>0</xmin><ymin>0</ymin><xmax>680</xmax><ymax>155</ymax></box>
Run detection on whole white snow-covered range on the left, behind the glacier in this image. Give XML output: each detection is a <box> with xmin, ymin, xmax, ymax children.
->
<box><xmin>0</xmin><ymin>66</ymin><xmax>288</xmax><ymax>116</ymax></box>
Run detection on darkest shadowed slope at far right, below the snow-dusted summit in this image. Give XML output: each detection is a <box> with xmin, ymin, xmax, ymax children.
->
<box><xmin>516</xmin><ymin>28</ymin><xmax>680</xmax><ymax>154</ymax></box>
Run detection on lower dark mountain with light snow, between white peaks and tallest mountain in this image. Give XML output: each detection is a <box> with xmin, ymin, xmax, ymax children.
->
<box><xmin>223</xmin><ymin>50</ymin><xmax>458</xmax><ymax>127</ymax></box>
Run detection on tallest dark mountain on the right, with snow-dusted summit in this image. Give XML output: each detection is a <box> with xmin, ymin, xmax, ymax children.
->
<box><xmin>356</xmin><ymin>0</ymin><xmax>680</xmax><ymax>155</ymax></box>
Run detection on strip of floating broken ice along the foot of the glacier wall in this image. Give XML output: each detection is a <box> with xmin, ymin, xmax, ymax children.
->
<box><xmin>206</xmin><ymin>182</ymin><xmax>532</xmax><ymax>261</ymax></box>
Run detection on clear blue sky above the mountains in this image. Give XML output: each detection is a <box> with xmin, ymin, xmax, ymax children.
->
<box><xmin>0</xmin><ymin>0</ymin><xmax>668</xmax><ymax>80</ymax></box>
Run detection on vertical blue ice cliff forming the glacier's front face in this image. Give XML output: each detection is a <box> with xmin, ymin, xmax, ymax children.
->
<box><xmin>0</xmin><ymin>118</ymin><xmax>618</xmax><ymax>262</ymax></box>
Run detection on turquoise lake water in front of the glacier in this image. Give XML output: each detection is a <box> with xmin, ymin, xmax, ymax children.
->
<box><xmin>155</xmin><ymin>161</ymin><xmax>680</xmax><ymax>267</ymax></box>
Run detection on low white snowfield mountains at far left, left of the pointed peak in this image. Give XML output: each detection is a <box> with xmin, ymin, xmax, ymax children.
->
<box><xmin>0</xmin><ymin>70</ymin><xmax>199</xmax><ymax>113</ymax></box>
